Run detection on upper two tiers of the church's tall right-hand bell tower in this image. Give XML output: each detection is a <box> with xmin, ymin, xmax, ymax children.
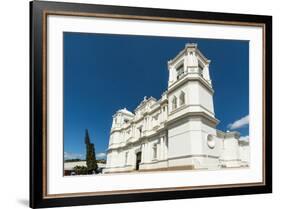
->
<box><xmin>168</xmin><ymin>43</ymin><xmax>215</xmax><ymax>117</ymax></box>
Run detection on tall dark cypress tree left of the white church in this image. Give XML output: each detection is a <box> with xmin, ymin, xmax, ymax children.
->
<box><xmin>85</xmin><ymin>129</ymin><xmax>98</xmax><ymax>174</ymax></box>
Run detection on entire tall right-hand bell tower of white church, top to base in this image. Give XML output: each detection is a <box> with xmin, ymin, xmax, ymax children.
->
<box><xmin>167</xmin><ymin>43</ymin><xmax>220</xmax><ymax>168</ymax></box>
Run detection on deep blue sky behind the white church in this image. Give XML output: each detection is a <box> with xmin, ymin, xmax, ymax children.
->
<box><xmin>63</xmin><ymin>32</ymin><xmax>249</xmax><ymax>158</ymax></box>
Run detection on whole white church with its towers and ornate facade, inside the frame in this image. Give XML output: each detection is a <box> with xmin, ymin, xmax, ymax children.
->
<box><xmin>103</xmin><ymin>44</ymin><xmax>250</xmax><ymax>173</ymax></box>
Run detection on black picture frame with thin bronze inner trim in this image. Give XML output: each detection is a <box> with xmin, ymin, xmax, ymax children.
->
<box><xmin>30</xmin><ymin>1</ymin><xmax>272</xmax><ymax>208</ymax></box>
